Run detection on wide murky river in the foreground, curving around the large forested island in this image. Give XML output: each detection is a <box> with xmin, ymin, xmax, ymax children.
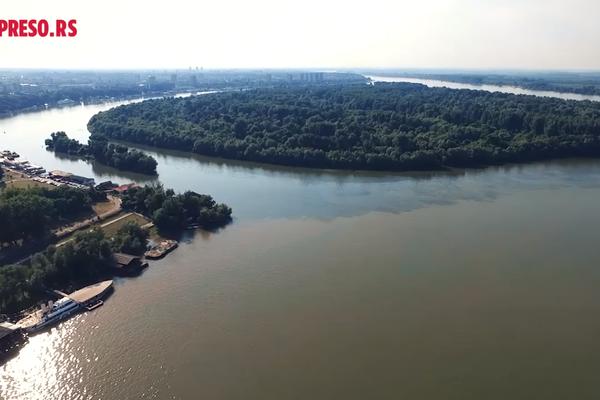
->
<box><xmin>0</xmin><ymin>83</ymin><xmax>600</xmax><ymax>400</ymax></box>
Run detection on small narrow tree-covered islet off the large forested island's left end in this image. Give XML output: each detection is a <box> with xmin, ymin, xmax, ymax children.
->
<box><xmin>45</xmin><ymin>132</ymin><xmax>157</xmax><ymax>175</ymax></box>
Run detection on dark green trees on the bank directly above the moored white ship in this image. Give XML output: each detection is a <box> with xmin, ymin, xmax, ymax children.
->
<box><xmin>0</xmin><ymin>230</ymin><xmax>112</xmax><ymax>314</ymax></box>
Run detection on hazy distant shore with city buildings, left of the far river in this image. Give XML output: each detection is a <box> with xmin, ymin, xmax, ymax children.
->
<box><xmin>0</xmin><ymin>69</ymin><xmax>365</xmax><ymax>116</ymax></box>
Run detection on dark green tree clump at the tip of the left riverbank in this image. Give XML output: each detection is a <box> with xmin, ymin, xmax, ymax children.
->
<box><xmin>122</xmin><ymin>185</ymin><xmax>231</xmax><ymax>232</ymax></box>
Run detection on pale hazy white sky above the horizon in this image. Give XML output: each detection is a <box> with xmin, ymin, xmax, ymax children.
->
<box><xmin>0</xmin><ymin>0</ymin><xmax>600</xmax><ymax>70</ymax></box>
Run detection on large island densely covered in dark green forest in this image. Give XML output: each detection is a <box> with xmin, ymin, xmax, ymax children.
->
<box><xmin>88</xmin><ymin>83</ymin><xmax>600</xmax><ymax>170</ymax></box>
